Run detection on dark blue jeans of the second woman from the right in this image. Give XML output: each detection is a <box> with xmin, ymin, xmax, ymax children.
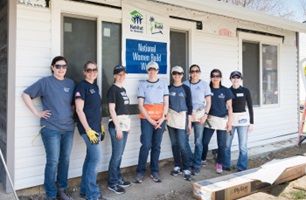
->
<box><xmin>202</xmin><ymin>128</ymin><xmax>229</xmax><ymax>165</ymax></box>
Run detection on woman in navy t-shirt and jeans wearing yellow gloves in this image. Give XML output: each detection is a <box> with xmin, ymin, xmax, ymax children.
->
<box><xmin>74</xmin><ymin>61</ymin><xmax>105</xmax><ymax>200</ymax></box>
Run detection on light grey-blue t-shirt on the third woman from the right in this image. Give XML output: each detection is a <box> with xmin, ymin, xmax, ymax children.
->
<box><xmin>183</xmin><ymin>80</ymin><xmax>212</xmax><ymax>110</ymax></box>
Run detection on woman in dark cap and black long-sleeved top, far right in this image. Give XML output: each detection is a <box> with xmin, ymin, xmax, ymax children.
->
<box><xmin>224</xmin><ymin>71</ymin><xmax>254</xmax><ymax>171</ymax></box>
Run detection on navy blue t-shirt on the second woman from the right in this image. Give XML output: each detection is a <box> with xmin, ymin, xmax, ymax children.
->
<box><xmin>209</xmin><ymin>86</ymin><xmax>234</xmax><ymax>117</ymax></box>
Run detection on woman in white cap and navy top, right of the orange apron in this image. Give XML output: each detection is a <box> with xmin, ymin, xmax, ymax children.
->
<box><xmin>167</xmin><ymin>66</ymin><xmax>192</xmax><ymax>181</ymax></box>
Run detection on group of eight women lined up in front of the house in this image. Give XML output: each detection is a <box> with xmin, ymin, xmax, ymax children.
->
<box><xmin>22</xmin><ymin>56</ymin><xmax>253</xmax><ymax>200</ymax></box>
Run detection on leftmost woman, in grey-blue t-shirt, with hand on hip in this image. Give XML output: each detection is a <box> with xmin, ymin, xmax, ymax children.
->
<box><xmin>22</xmin><ymin>56</ymin><xmax>74</xmax><ymax>200</ymax></box>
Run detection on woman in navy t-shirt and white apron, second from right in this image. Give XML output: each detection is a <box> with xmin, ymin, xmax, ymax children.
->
<box><xmin>202</xmin><ymin>69</ymin><xmax>233</xmax><ymax>174</ymax></box>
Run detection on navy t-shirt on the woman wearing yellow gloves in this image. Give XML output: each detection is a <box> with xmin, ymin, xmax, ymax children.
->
<box><xmin>74</xmin><ymin>80</ymin><xmax>102</xmax><ymax>134</ymax></box>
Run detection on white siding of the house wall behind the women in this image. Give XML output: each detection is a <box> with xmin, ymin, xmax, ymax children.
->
<box><xmin>15</xmin><ymin>1</ymin><xmax>298</xmax><ymax>189</ymax></box>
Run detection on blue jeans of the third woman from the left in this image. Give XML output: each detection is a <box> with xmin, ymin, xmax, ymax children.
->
<box><xmin>107</xmin><ymin>127</ymin><xmax>128</xmax><ymax>187</ymax></box>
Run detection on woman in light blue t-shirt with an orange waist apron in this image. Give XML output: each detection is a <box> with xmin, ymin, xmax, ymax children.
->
<box><xmin>135</xmin><ymin>61</ymin><xmax>169</xmax><ymax>183</ymax></box>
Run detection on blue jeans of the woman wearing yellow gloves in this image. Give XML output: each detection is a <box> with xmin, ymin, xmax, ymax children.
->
<box><xmin>80</xmin><ymin>133</ymin><xmax>102</xmax><ymax>200</ymax></box>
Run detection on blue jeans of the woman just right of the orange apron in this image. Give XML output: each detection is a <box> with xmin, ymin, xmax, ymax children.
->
<box><xmin>168</xmin><ymin>126</ymin><xmax>190</xmax><ymax>170</ymax></box>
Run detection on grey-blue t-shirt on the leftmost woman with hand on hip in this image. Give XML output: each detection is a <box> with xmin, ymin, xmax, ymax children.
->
<box><xmin>24</xmin><ymin>75</ymin><xmax>74</xmax><ymax>131</ymax></box>
